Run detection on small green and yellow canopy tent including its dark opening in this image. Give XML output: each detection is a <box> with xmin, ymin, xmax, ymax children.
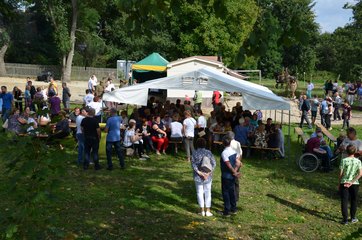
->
<box><xmin>132</xmin><ymin>53</ymin><xmax>168</xmax><ymax>83</ymax></box>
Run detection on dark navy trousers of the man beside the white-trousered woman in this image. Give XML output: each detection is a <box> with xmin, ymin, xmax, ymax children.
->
<box><xmin>221</xmin><ymin>178</ymin><xmax>236</xmax><ymax>214</ymax></box>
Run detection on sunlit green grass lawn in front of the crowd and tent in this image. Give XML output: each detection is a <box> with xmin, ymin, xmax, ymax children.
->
<box><xmin>0</xmin><ymin>123</ymin><xmax>362</xmax><ymax>240</ymax></box>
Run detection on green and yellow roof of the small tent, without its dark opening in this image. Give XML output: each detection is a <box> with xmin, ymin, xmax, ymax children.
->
<box><xmin>132</xmin><ymin>53</ymin><xmax>168</xmax><ymax>72</ymax></box>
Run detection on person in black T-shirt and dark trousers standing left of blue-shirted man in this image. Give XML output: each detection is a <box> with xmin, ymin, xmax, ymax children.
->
<box><xmin>80</xmin><ymin>108</ymin><xmax>101</xmax><ymax>170</ymax></box>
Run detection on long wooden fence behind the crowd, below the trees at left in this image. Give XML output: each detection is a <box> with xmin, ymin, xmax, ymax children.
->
<box><xmin>5</xmin><ymin>63</ymin><xmax>117</xmax><ymax>81</ymax></box>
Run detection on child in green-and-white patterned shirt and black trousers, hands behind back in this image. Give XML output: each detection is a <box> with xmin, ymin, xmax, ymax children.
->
<box><xmin>339</xmin><ymin>145</ymin><xmax>362</xmax><ymax>225</ymax></box>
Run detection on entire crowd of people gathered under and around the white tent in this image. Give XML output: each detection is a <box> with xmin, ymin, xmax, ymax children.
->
<box><xmin>0</xmin><ymin>75</ymin><xmax>362</xmax><ymax>221</ymax></box>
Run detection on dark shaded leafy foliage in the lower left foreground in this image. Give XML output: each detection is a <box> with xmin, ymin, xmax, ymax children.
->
<box><xmin>0</xmin><ymin>134</ymin><xmax>65</xmax><ymax>239</ymax></box>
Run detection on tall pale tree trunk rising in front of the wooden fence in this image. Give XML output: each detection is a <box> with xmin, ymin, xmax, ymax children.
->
<box><xmin>62</xmin><ymin>0</ymin><xmax>78</xmax><ymax>82</ymax></box>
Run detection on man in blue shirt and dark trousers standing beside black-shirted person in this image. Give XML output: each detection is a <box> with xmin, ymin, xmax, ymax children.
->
<box><xmin>105</xmin><ymin>108</ymin><xmax>125</xmax><ymax>170</ymax></box>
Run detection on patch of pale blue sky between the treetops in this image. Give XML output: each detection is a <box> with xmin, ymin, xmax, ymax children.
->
<box><xmin>314</xmin><ymin>0</ymin><xmax>353</xmax><ymax>33</ymax></box>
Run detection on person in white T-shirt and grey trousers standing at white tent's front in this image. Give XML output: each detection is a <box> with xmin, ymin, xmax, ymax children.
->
<box><xmin>183</xmin><ymin>110</ymin><xmax>196</xmax><ymax>162</ymax></box>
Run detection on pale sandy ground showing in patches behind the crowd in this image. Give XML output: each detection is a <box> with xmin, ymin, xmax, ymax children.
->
<box><xmin>0</xmin><ymin>77</ymin><xmax>362</xmax><ymax>125</ymax></box>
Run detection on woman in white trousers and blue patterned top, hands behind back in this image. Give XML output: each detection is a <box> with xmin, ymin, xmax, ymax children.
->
<box><xmin>191</xmin><ymin>138</ymin><xmax>216</xmax><ymax>217</ymax></box>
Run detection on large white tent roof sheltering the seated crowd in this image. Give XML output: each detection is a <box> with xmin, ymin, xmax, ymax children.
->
<box><xmin>103</xmin><ymin>67</ymin><xmax>290</xmax><ymax>110</ymax></box>
